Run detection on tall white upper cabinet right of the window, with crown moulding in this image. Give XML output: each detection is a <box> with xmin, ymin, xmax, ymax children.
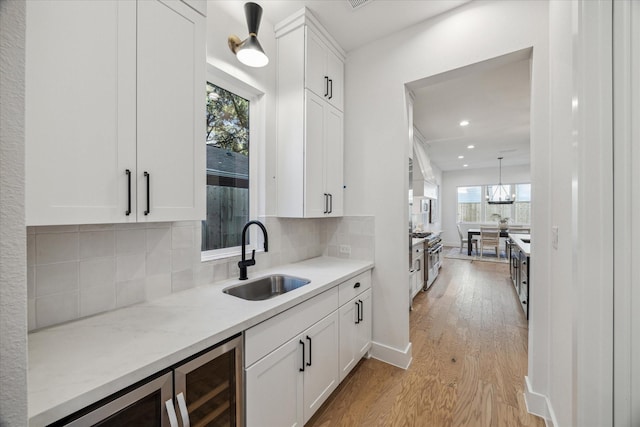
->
<box><xmin>276</xmin><ymin>9</ymin><xmax>344</xmax><ymax>218</ymax></box>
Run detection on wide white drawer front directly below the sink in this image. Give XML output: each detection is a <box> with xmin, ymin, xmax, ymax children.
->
<box><xmin>244</xmin><ymin>286</ymin><xmax>338</xmax><ymax>367</ymax></box>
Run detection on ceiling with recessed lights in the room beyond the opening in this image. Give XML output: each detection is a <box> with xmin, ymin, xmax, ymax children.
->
<box><xmin>409</xmin><ymin>49</ymin><xmax>531</xmax><ymax>171</ymax></box>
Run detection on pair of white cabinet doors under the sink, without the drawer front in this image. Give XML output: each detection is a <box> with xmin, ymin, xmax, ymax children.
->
<box><xmin>246</xmin><ymin>311</ymin><xmax>340</xmax><ymax>427</ymax></box>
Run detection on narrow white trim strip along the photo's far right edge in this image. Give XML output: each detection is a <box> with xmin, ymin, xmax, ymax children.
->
<box><xmin>613</xmin><ymin>2</ymin><xmax>640</xmax><ymax>427</ymax></box>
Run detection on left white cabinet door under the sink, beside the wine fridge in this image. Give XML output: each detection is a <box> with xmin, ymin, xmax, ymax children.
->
<box><xmin>245</xmin><ymin>337</ymin><xmax>305</xmax><ymax>427</ymax></box>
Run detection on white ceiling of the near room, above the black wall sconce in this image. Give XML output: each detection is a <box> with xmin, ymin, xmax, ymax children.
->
<box><xmin>215</xmin><ymin>0</ymin><xmax>471</xmax><ymax>52</ymax></box>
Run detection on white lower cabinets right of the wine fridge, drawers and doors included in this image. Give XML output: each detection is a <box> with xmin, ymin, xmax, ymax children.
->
<box><xmin>245</xmin><ymin>271</ymin><xmax>372</xmax><ymax>427</ymax></box>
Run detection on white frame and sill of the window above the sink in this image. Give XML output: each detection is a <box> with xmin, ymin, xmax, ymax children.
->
<box><xmin>200</xmin><ymin>64</ymin><xmax>265</xmax><ymax>262</ymax></box>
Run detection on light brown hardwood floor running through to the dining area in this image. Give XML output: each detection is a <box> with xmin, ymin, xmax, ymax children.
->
<box><xmin>306</xmin><ymin>259</ymin><xmax>545</xmax><ymax>427</ymax></box>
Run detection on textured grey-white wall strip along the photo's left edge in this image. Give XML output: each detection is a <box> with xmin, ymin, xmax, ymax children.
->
<box><xmin>0</xmin><ymin>0</ymin><xmax>27</xmax><ymax>426</ymax></box>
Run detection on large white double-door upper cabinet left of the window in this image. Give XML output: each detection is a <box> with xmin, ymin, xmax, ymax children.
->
<box><xmin>25</xmin><ymin>0</ymin><xmax>206</xmax><ymax>225</ymax></box>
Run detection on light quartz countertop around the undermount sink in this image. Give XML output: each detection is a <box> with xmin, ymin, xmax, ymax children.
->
<box><xmin>28</xmin><ymin>257</ymin><xmax>373</xmax><ymax>426</ymax></box>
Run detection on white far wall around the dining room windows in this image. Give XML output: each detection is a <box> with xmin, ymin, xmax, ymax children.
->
<box><xmin>440</xmin><ymin>165</ymin><xmax>531</xmax><ymax>246</ymax></box>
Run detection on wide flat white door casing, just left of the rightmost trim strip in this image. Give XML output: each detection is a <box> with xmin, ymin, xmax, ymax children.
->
<box><xmin>571</xmin><ymin>0</ymin><xmax>613</xmax><ymax>426</ymax></box>
